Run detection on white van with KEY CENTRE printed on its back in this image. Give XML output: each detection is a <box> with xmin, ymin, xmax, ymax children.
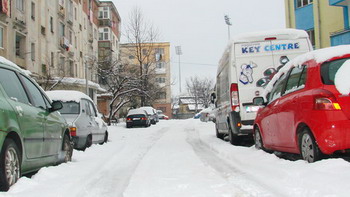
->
<box><xmin>212</xmin><ymin>29</ymin><xmax>312</xmax><ymax>144</ymax></box>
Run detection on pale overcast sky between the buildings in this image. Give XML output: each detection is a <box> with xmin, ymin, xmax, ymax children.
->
<box><xmin>113</xmin><ymin>0</ymin><xmax>285</xmax><ymax>95</ymax></box>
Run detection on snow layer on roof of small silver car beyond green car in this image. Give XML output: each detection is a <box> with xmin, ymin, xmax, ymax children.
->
<box><xmin>46</xmin><ymin>90</ymin><xmax>93</xmax><ymax>103</ymax></box>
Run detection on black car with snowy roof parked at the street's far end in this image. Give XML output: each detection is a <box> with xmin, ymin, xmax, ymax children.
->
<box><xmin>126</xmin><ymin>108</ymin><xmax>151</xmax><ymax>128</ymax></box>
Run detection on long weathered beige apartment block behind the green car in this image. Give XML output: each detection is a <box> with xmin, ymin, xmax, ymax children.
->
<box><xmin>0</xmin><ymin>0</ymin><xmax>120</xmax><ymax>100</ymax></box>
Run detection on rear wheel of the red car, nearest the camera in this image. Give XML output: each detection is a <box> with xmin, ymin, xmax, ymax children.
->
<box><xmin>299</xmin><ymin>127</ymin><xmax>322</xmax><ymax>163</ymax></box>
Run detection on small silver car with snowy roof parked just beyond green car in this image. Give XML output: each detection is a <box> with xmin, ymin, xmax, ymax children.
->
<box><xmin>46</xmin><ymin>90</ymin><xmax>108</xmax><ymax>150</ymax></box>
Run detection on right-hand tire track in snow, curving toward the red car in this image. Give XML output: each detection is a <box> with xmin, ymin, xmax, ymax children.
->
<box><xmin>186</xmin><ymin>121</ymin><xmax>284</xmax><ymax>197</ymax></box>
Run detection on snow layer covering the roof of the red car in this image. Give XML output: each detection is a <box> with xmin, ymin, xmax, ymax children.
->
<box><xmin>262</xmin><ymin>45</ymin><xmax>350</xmax><ymax>97</ymax></box>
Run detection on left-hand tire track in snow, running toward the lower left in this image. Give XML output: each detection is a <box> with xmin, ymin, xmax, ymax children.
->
<box><xmin>69</xmin><ymin>127</ymin><xmax>168</xmax><ymax>197</ymax></box>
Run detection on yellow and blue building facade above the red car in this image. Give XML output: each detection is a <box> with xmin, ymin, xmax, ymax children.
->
<box><xmin>285</xmin><ymin>0</ymin><xmax>348</xmax><ymax>49</ymax></box>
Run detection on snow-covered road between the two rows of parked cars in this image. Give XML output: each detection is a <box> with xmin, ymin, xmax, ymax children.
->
<box><xmin>0</xmin><ymin>120</ymin><xmax>350</xmax><ymax>197</ymax></box>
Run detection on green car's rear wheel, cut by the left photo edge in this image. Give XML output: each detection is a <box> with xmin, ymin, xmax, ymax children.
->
<box><xmin>0</xmin><ymin>139</ymin><xmax>21</xmax><ymax>191</ymax></box>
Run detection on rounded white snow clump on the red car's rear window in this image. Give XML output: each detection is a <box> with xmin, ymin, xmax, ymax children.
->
<box><xmin>334</xmin><ymin>60</ymin><xmax>350</xmax><ymax>95</ymax></box>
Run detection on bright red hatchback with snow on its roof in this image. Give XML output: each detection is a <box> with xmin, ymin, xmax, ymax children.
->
<box><xmin>253</xmin><ymin>45</ymin><xmax>350</xmax><ymax>162</ymax></box>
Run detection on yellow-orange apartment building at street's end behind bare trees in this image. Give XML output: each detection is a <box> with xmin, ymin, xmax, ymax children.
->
<box><xmin>120</xmin><ymin>42</ymin><xmax>172</xmax><ymax>118</ymax></box>
